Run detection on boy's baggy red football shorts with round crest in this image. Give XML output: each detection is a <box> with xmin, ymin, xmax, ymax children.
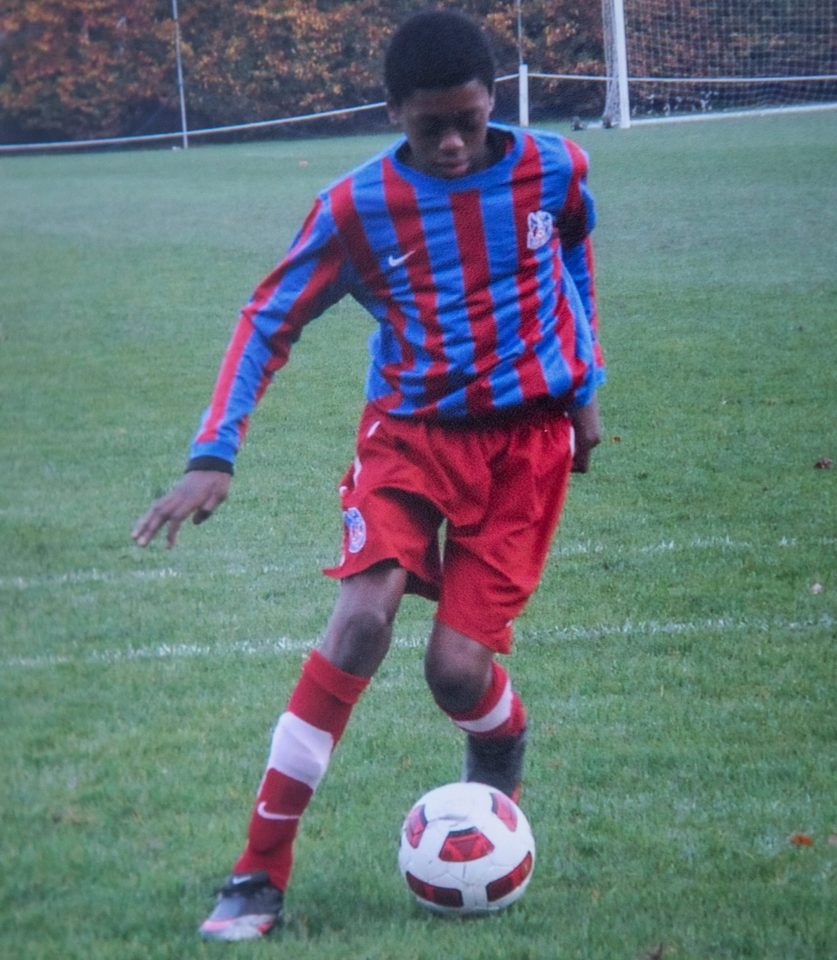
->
<box><xmin>324</xmin><ymin>405</ymin><xmax>572</xmax><ymax>653</ymax></box>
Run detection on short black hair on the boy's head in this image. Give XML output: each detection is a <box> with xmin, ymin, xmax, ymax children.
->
<box><xmin>384</xmin><ymin>10</ymin><xmax>496</xmax><ymax>104</ymax></box>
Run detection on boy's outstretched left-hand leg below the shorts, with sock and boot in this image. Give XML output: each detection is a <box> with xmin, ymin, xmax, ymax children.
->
<box><xmin>201</xmin><ymin>564</ymin><xmax>406</xmax><ymax>940</ymax></box>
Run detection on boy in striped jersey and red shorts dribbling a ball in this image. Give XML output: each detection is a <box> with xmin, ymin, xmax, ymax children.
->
<box><xmin>133</xmin><ymin>5</ymin><xmax>604</xmax><ymax>940</ymax></box>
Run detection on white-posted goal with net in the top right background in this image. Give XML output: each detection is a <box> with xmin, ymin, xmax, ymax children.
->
<box><xmin>603</xmin><ymin>0</ymin><xmax>837</xmax><ymax>126</ymax></box>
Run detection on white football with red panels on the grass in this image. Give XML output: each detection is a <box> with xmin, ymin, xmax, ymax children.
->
<box><xmin>398</xmin><ymin>783</ymin><xmax>535</xmax><ymax>916</ymax></box>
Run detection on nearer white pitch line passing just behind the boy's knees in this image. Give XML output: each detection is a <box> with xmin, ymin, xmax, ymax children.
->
<box><xmin>0</xmin><ymin>615</ymin><xmax>835</xmax><ymax>670</ymax></box>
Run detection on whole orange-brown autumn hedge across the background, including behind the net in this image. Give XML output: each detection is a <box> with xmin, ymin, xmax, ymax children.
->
<box><xmin>0</xmin><ymin>0</ymin><xmax>837</xmax><ymax>142</ymax></box>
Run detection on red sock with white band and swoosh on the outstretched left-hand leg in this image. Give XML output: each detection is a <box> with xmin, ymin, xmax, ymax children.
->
<box><xmin>233</xmin><ymin>650</ymin><xmax>369</xmax><ymax>890</ymax></box>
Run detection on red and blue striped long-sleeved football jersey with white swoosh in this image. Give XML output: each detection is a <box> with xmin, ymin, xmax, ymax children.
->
<box><xmin>191</xmin><ymin>124</ymin><xmax>604</xmax><ymax>462</ymax></box>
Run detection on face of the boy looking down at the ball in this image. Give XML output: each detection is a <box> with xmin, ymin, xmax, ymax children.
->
<box><xmin>387</xmin><ymin>80</ymin><xmax>494</xmax><ymax>180</ymax></box>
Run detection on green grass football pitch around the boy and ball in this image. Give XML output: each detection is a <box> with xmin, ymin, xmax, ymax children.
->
<box><xmin>0</xmin><ymin>113</ymin><xmax>837</xmax><ymax>960</ymax></box>
